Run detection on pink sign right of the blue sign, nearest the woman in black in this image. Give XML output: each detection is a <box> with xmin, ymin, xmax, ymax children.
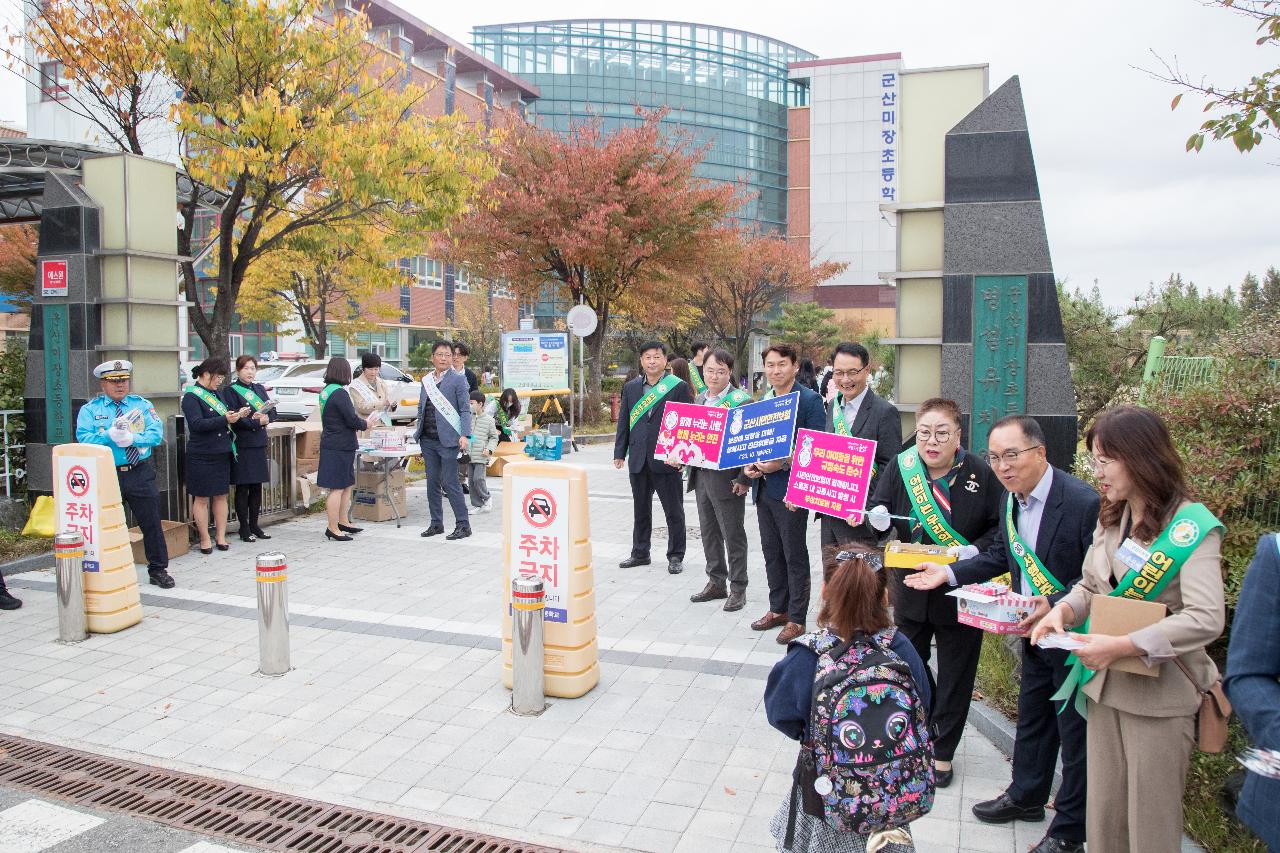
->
<box><xmin>787</xmin><ymin>429</ymin><xmax>876</xmax><ymax>519</ymax></box>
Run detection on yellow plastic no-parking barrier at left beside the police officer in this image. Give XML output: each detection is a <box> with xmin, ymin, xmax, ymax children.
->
<box><xmin>54</xmin><ymin>444</ymin><xmax>142</xmax><ymax>634</ymax></box>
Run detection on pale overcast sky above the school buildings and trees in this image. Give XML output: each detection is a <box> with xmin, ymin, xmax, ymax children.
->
<box><xmin>0</xmin><ymin>0</ymin><xmax>1280</xmax><ymax>304</ymax></box>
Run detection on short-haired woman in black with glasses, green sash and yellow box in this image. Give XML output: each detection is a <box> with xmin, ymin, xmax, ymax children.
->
<box><xmin>867</xmin><ymin>397</ymin><xmax>1005</xmax><ymax>788</ymax></box>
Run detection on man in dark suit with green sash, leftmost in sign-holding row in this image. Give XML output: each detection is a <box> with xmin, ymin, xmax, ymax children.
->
<box><xmin>613</xmin><ymin>341</ymin><xmax>694</xmax><ymax>575</ymax></box>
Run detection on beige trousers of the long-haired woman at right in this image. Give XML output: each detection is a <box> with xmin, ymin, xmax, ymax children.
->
<box><xmin>1084</xmin><ymin>696</ymin><xmax>1196</xmax><ymax>853</ymax></box>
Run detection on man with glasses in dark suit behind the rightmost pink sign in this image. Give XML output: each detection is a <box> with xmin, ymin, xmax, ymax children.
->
<box><xmin>818</xmin><ymin>343</ymin><xmax>902</xmax><ymax>579</ymax></box>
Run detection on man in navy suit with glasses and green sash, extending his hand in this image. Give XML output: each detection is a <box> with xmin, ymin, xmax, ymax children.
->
<box><xmin>906</xmin><ymin>415</ymin><xmax>1100</xmax><ymax>853</ymax></box>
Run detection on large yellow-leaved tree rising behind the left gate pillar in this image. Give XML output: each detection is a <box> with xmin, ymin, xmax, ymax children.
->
<box><xmin>28</xmin><ymin>0</ymin><xmax>493</xmax><ymax>356</ymax></box>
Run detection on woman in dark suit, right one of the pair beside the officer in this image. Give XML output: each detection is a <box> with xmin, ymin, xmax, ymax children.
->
<box><xmin>223</xmin><ymin>355</ymin><xmax>275</xmax><ymax>542</ymax></box>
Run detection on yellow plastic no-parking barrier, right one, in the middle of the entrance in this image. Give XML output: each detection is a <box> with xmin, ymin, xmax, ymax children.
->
<box><xmin>502</xmin><ymin>460</ymin><xmax>600</xmax><ymax>699</ymax></box>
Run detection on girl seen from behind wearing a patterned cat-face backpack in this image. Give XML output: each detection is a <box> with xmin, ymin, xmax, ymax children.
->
<box><xmin>764</xmin><ymin>547</ymin><xmax>933</xmax><ymax>853</ymax></box>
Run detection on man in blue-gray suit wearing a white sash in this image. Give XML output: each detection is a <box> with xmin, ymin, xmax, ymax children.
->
<box><xmin>413</xmin><ymin>341</ymin><xmax>471</xmax><ymax>539</ymax></box>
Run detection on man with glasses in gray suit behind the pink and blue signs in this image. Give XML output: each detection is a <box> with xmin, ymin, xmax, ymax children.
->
<box><xmin>687</xmin><ymin>350</ymin><xmax>751</xmax><ymax>612</ymax></box>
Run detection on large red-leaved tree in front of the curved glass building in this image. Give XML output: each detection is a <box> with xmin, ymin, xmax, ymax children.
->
<box><xmin>449</xmin><ymin>110</ymin><xmax>744</xmax><ymax>394</ymax></box>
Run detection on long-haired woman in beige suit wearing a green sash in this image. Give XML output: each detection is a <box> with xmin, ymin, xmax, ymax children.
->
<box><xmin>1032</xmin><ymin>406</ymin><xmax>1226</xmax><ymax>853</ymax></box>
